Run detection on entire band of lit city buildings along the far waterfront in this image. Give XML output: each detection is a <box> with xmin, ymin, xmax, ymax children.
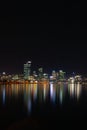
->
<box><xmin>0</xmin><ymin>61</ymin><xmax>82</xmax><ymax>83</ymax></box>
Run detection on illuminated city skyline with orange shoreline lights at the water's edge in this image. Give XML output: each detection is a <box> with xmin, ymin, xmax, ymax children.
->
<box><xmin>0</xmin><ymin>61</ymin><xmax>83</xmax><ymax>84</ymax></box>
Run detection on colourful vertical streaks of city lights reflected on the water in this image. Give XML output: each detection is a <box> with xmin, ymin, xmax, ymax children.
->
<box><xmin>0</xmin><ymin>83</ymin><xmax>82</xmax><ymax>113</ymax></box>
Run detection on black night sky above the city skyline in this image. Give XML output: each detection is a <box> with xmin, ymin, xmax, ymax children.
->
<box><xmin>0</xmin><ymin>3</ymin><xmax>87</xmax><ymax>74</ymax></box>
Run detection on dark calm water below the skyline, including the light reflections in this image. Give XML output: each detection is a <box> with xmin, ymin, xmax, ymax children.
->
<box><xmin>0</xmin><ymin>83</ymin><xmax>87</xmax><ymax>130</ymax></box>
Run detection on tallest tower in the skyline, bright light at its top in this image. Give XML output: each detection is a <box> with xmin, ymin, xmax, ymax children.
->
<box><xmin>24</xmin><ymin>61</ymin><xmax>31</xmax><ymax>79</ymax></box>
